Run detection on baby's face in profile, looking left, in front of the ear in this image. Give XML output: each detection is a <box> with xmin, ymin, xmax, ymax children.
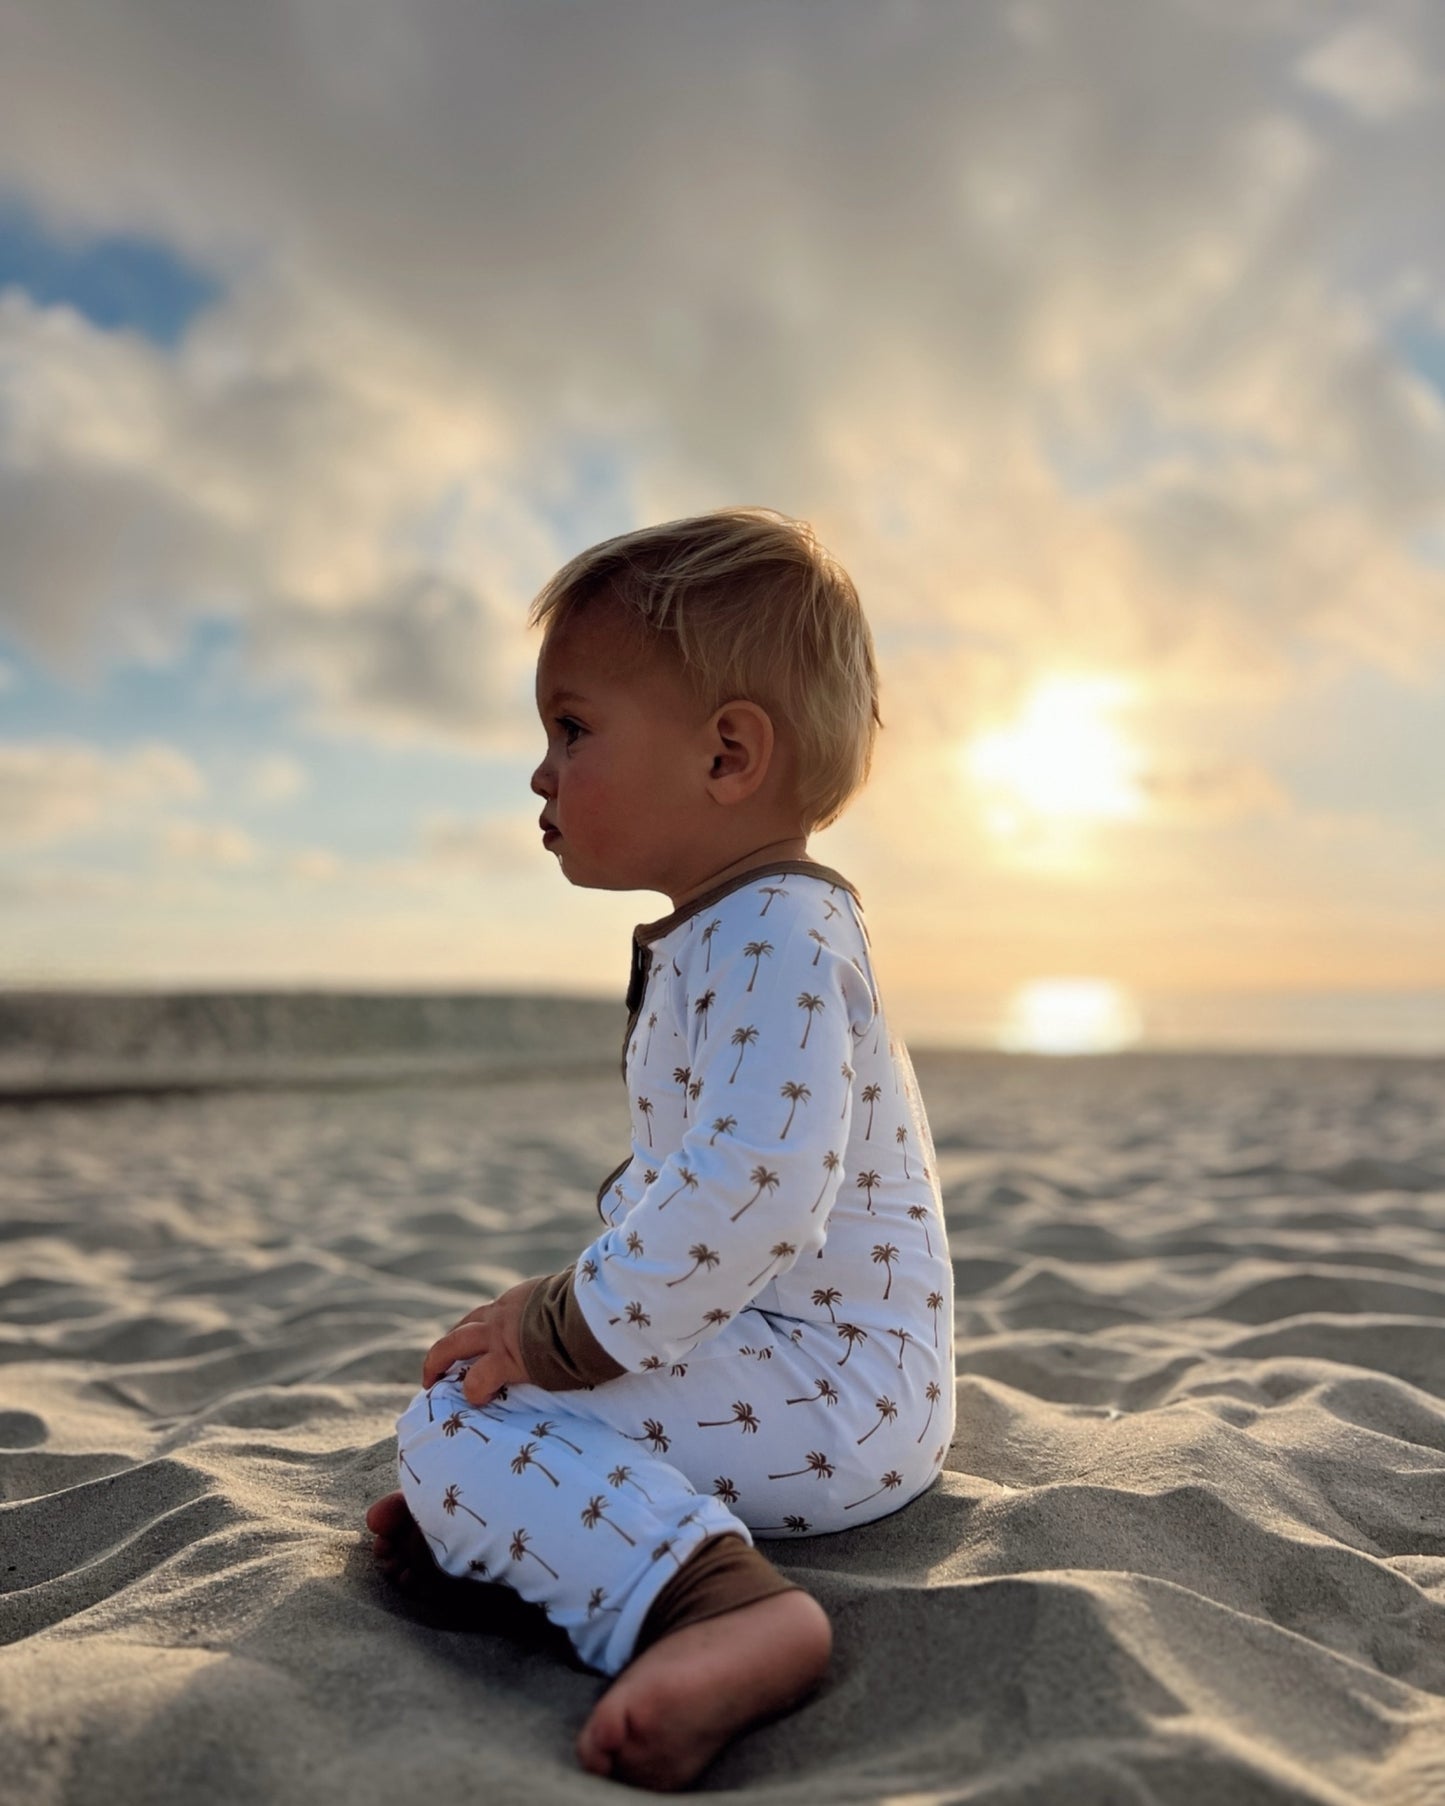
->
<box><xmin>531</xmin><ymin>607</ymin><xmax>712</xmax><ymax>896</ymax></box>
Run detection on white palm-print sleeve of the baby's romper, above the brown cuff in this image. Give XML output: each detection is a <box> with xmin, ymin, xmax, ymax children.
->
<box><xmin>573</xmin><ymin>885</ymin><xmax>874</xmax><ymax>1371</ymax></box>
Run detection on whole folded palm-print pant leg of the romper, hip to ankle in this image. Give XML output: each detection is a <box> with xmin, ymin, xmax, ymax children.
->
<box><xmin>397</xmin><ymin>1311</ymin><xmax>952</xmax><ymax>1674</ymax></box>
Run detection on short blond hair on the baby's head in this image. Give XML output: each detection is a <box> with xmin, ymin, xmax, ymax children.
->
<box><xmin>527</xmin><ymin>507</ymin><xmax>883</xmax><ymax>831</ymax></box>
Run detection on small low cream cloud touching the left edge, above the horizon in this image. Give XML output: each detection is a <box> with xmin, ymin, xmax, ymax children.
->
<box><xmin>0</xmin><ymin>740</ymin><xmax>206</xmax><ymax>843</ymax></box>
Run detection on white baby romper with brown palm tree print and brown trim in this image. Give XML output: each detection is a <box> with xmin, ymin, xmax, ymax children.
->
<box><xmin>397</xmin><ymin>861</ymin><xmax>954</xmax><ymax>1674</ymax></box>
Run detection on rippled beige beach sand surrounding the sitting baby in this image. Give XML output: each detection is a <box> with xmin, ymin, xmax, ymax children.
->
<box><xmin>0</xmin><ymin>1057</ymin><xmax>1445</xmax><ymax>1806</ymax></box>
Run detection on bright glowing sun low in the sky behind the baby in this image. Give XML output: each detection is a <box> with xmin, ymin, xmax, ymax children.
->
<box><xmin>963</xmin><ymin>675</ymin><xmax>1145</xmax><ymax>836</ymax></box>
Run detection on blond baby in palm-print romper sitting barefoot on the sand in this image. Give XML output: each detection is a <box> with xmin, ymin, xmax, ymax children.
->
<box><xmin>367</xmin><ymin>507</ymin><xmax>954</xmax><ymax>1788</ymax></box>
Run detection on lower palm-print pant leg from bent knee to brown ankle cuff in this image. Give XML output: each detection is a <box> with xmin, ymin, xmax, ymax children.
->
<box><xmin>397</xmin><ymin>1365</ymin><xmax>753</xmax><ymax>1674</ymax></box>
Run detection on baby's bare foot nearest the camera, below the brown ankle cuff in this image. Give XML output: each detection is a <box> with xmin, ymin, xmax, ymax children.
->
<box><xmin>576</xmin><ymin>1593</ymin><xmax>833</xmax><ymax>1792</ymax></box>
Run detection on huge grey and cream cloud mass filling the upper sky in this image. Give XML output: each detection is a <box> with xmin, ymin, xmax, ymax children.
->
<box><xmin>0</xmin><ymin>0</ymin><xmax>1445</xmax><ymax>744</ymax></box>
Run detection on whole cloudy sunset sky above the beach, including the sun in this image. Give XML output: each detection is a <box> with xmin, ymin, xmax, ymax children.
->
<box><xmin>0</xmin><ymin>0</ymin><xmax>1445</xmax><ymax>1051</ymax></box>
